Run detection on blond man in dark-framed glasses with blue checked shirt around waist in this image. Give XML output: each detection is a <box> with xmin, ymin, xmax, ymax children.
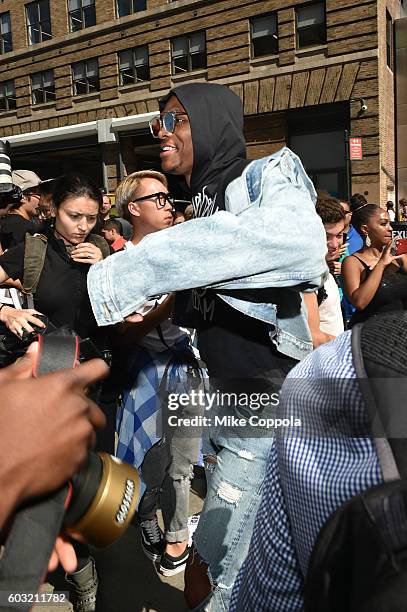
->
<box><xmin>116</xmin><ymin>170</ymin><xmax>201</xmax><ymax>576</ymax></box>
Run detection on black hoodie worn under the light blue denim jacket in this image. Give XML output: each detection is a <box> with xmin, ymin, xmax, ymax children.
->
<box><xmin>160</xmin><ymin>83</ymin><xmax>294</xmax><ymax>379</ymax></box>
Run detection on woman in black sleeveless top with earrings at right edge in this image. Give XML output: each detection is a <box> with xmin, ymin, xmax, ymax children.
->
<box><xmin>342</xmin><ymin>203</ymin><xmax>407</xmax><ymax>327</ymax></box>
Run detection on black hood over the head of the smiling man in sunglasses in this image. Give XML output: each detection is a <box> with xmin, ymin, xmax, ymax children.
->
<box><xmin>160</xmin><ymin>83</ymin><xmax>249</xmax><ymax>216</ymax></box>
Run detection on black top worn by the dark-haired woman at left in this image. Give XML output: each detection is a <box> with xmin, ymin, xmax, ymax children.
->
<box><xmin>0</xmin><ymin>236</ymin><xmax>104</xmax><ymax>344</ymax></box>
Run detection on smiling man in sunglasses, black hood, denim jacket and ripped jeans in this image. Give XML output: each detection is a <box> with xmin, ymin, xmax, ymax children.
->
<box><xmin>88</xmin><ymin>83</ymin><xmax>326</xmax><ymax>612</ymax></box>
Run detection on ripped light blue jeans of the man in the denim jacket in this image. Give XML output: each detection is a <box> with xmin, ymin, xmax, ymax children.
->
<box><xmin>194</xmin><ymin>406</ymin><xmax>274</xmax><ymax>612</ymax></box>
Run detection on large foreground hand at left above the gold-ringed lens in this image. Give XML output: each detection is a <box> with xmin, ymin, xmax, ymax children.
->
<box><xmin>0</xmin><ymin>344</ymin><xmax>108</xmax><ymax>528</ymax></box>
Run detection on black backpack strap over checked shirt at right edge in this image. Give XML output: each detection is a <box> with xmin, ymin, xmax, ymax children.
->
<box><xmin>352</xmin><ymin>312</ymin><xmax>407</xmax><ymax>482</ymax></box>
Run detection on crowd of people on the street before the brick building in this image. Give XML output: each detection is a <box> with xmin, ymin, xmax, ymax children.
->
<box><xmin>0</xmin><ymin>83</ymin><xmax>407</xmax><ymax>612</ymax></box>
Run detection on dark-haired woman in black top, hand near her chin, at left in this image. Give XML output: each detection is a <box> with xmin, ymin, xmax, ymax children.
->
<box><xmin>0</xmin><ymin>174</ymin><xmax>109</xmax><ymax>338</ymax></box>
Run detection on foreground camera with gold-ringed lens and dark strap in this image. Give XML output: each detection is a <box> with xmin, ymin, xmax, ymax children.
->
<box><xmin>0</xmin><ymin>330</ymin><xmax>140</xmax><ymax>610</ymax></box>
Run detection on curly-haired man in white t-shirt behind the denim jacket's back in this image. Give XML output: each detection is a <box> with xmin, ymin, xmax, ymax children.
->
<box><xmin>304</xmin><ymin>197</ymin><xmax>346</xmax><ymax>348</ymax></box>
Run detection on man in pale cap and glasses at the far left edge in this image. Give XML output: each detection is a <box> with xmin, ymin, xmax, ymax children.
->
<box><xmin>0</xmin><ymin>170</ymin><xmax>41</xmax><ymax>250</ymax></box>
